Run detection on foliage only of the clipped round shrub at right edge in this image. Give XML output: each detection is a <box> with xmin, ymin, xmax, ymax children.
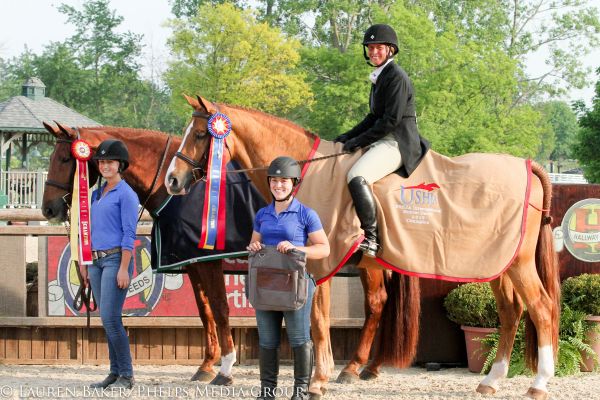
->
<box><xmin>562</xmin><ymin>274</ymin><xmax>600</xmax><ymax>315</ymax></box>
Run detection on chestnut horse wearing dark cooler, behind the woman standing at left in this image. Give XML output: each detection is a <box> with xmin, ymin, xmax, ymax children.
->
<box><xmin>42</xmin><ymin>123</ymin><xmax>235</xmax><ymax>385</ymax></box>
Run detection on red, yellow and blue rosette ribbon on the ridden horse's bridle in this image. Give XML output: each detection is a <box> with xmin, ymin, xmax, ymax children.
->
<box><xmin>198</xmin><ymin>113</ymin><xmax>231</xmax><ymax>250</ymax></box>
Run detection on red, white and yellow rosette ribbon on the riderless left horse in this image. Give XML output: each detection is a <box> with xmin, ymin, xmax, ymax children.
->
<box><xmin>70</xmin><ymin>139</ymin><xmax>92</xmax><ymax>265</ymax></box>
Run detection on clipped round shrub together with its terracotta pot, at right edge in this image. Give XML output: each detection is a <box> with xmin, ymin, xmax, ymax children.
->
<box><xmin>562</xmin><ymin>274</ymin><xmax>600</xmax><ymax>372</ymax></box>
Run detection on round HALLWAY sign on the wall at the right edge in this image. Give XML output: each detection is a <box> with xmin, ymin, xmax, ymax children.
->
<box><xmin>561</xmin><ymin>199</ymin><xmax>600</xmax><ymax>262</ymax></box>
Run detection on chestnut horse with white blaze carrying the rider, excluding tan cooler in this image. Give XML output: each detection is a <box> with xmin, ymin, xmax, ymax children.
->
<box><xmin>165</xmin><ymin>96</ymin><xmax>560</xmax><ymax>399</ymax></box>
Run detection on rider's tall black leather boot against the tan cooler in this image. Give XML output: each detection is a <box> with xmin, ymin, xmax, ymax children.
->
<box><xmin>348</xmin><ymin>176</ymin><xmax>379</xmax><ymax>257</ymax></box>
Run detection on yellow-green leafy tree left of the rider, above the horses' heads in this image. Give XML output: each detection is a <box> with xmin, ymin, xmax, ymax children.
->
<box><xmin>166</xmin><ymin>4</ymin><xmax>312</xmax><ymax>116</ymax></box>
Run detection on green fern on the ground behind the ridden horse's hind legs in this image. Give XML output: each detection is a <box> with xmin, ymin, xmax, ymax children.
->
<box><xmin>481</xmin><ymin>304</ymin><xmax>598</xmax><ymax>378</ymax></box>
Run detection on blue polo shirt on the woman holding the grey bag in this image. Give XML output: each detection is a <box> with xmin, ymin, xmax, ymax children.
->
<box><xmin>254</xmin><ymin>198</ymin><xmax>323</xmax><ymax>246</ymax></box>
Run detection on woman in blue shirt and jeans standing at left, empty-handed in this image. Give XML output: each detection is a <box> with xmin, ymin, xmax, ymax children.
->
<box><xmin>82</xmin><ymin>139</ymin><xmax>139</xmax><ymax>389</ymax></box>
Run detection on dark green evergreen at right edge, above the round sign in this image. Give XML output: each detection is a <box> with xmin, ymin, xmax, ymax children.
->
<box><xmin>573</xmin><ymin>68</ymin><xmax>600</xmax><ymax>183</ymax></box>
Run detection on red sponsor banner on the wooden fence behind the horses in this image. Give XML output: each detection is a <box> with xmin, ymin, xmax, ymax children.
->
<box><xmin>48</xmin><ymin>236</ymin><xmax>254</xmax><ymax>317</ymax></box>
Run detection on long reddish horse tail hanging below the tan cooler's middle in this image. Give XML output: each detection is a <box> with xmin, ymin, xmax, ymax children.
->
<box><xmin>375</xmin><ymin>272</ymin><xmax>421</xmax><ymax>368</ymax></box>
